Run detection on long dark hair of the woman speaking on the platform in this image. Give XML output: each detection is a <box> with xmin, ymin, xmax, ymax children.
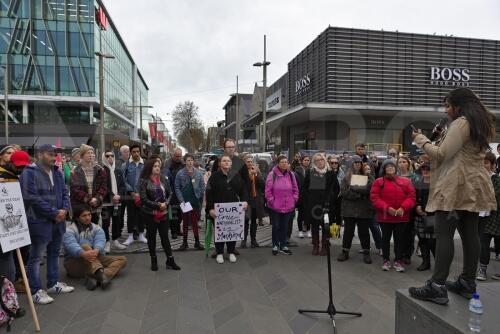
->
<box><xmin>444</xmin><ymin>88</ymin><xmax>495</xmax><ymax>151</ymax></box>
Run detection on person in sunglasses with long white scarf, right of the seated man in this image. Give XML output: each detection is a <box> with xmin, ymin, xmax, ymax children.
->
<box><xmin>102</xmin><ymin>150</ymin><xmax>127</xmax><ymax>253</ymax></box>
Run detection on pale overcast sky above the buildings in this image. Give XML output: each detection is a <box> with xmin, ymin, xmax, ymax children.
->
<box><xmin>103</xmin><ymin>0</ymin><xmax>500</xmax><ymax>134</ymax></box>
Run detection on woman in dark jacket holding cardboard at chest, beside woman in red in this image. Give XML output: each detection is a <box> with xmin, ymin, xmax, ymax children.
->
<box><xmin>337</xmin><ymin>155</ymin><xmax>375</xmax><ymax>264</ymax></box>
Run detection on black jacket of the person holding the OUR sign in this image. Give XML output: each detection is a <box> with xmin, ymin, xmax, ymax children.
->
<box><xmin>206</xmin><ymin>168</ymin><xmax>248</xmax><ymax>211</ymax></box>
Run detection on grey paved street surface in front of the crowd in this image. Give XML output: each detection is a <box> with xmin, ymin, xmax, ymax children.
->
<box><xmin>7</xmin><ymin>227</ymin><xmax>500</xmax><ymax>334</ymax></box>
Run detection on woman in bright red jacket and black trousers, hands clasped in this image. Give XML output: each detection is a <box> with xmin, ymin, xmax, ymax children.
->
<box><xmin>370</xmin><ymin>159</ymin><xmax>416</xmax><ymax>272</ymax></box>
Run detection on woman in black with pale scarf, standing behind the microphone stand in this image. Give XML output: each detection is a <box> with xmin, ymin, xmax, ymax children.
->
<box><xmin>303</xmin><ymin>153</ymin><xmax>340</xmax><ymax>255</ymax></box>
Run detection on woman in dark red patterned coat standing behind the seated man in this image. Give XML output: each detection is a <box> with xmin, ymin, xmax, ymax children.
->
<box><xmin>70</xmin><ymin>144</ymin><xmax>108</xmax><ymax>224</ymax></box>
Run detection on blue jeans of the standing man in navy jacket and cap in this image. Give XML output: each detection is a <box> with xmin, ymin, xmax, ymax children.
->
<box><xmin>27</xmin><ymin>233</ymin><xmax>62</xmax><ymax>294</ymax></box>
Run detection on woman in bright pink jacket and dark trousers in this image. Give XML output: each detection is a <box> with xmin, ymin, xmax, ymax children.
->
<box><xmin>265</xmin><ymin>155</ymin><xmax>299</xmax><ymax>255</ymax></box>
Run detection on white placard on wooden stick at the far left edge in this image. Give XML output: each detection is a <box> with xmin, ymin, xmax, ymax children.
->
<box><xmin>0</xmin><ymin>182</ymin><xmax>31</xmax><ymax>252</ymax></box>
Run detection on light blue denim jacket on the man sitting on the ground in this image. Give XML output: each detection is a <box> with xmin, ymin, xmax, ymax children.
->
<box><xmin>63</xmin><ymin>223</ymin><xmax>106</xmax><ymax>259</ymax></box>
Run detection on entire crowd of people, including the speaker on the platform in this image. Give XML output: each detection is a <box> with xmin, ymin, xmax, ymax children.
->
<box><xmin>0</xmin><ymin>89</ymin><xmax>500</xmax><ymax>310</ymax></box>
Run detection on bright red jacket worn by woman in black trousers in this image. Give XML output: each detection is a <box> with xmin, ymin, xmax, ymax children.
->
<box><xmin>370</xmin><ymin>176</ymin><xmax>415</xmax><ymax>223</ymax></box>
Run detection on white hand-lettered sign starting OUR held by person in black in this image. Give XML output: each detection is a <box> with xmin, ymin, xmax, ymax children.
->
<box><xmin>215</xmin><ymin>202</ymin><xmax>245</xmax><ymax>242</ymax></box>
